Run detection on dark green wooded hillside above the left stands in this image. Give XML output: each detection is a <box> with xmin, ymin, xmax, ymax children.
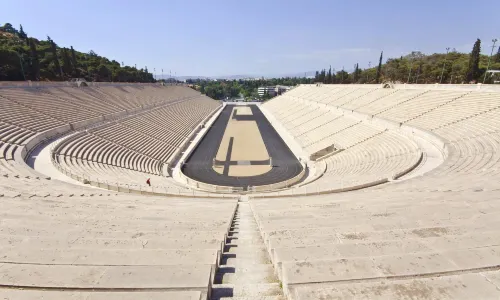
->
<box><xmin>0</xmin><ymin>23</ymin><xmax>154</xmax><ymax>82</ymax></box>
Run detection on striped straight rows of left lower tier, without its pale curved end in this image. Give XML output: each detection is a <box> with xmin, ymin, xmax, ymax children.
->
<box><xmin>54</xmin><ymin>97</ymin><xmax>219</xmax><ymax>175</ymax></box>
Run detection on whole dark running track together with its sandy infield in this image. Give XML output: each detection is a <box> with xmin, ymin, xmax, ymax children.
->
<box><xmin>182</xmin><ymin>105</ymin><xmax>305</xmax><ymax>191</ymax></box>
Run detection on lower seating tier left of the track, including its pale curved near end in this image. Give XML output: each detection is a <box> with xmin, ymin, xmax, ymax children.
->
<box><xmin>50</xmin><ymin>96</ymin><xmax>220</xmax><ymax>194</ymax></box>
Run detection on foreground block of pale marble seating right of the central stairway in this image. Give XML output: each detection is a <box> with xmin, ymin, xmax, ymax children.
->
<box><xmin>253</xmin><ymin>191</ymin><xmax>500</xmax><ymax>299</ymax></box>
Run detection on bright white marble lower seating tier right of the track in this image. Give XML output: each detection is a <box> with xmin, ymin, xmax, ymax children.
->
<box><xmin>264</xmin><ymin>86</ymin><xmax>422</xmax><ymax>195</ymax></box>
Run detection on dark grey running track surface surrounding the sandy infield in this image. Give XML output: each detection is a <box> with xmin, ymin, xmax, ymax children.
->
<box><xmin>182</xmin><ymin>105</ymin><xmax>302</xmax><ymax>188</ymax></box>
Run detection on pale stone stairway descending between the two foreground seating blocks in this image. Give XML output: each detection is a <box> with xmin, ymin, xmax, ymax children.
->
<box><xmin>212</xmin><ymin>202</ymin><xmax>285</xmax><ymax>300</ymax></box>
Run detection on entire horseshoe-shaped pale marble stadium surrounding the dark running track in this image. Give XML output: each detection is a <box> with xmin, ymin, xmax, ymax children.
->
<box><xmin>0</xmin><ymin>82</ymin><xmax>500</xmax><ymax>300</ymax></box>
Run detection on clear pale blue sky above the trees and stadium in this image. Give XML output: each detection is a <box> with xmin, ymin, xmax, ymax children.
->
<box><xmin>0</xmin><ymin>0</ymin><xmax>500</xmax><ymax>76</ymax></box>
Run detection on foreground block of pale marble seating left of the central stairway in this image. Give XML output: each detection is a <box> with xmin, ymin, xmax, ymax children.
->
<box><xmin>0</xmin><ymin>186</ymin><xmax>236</xmax><ymax>299</ymax></box>
